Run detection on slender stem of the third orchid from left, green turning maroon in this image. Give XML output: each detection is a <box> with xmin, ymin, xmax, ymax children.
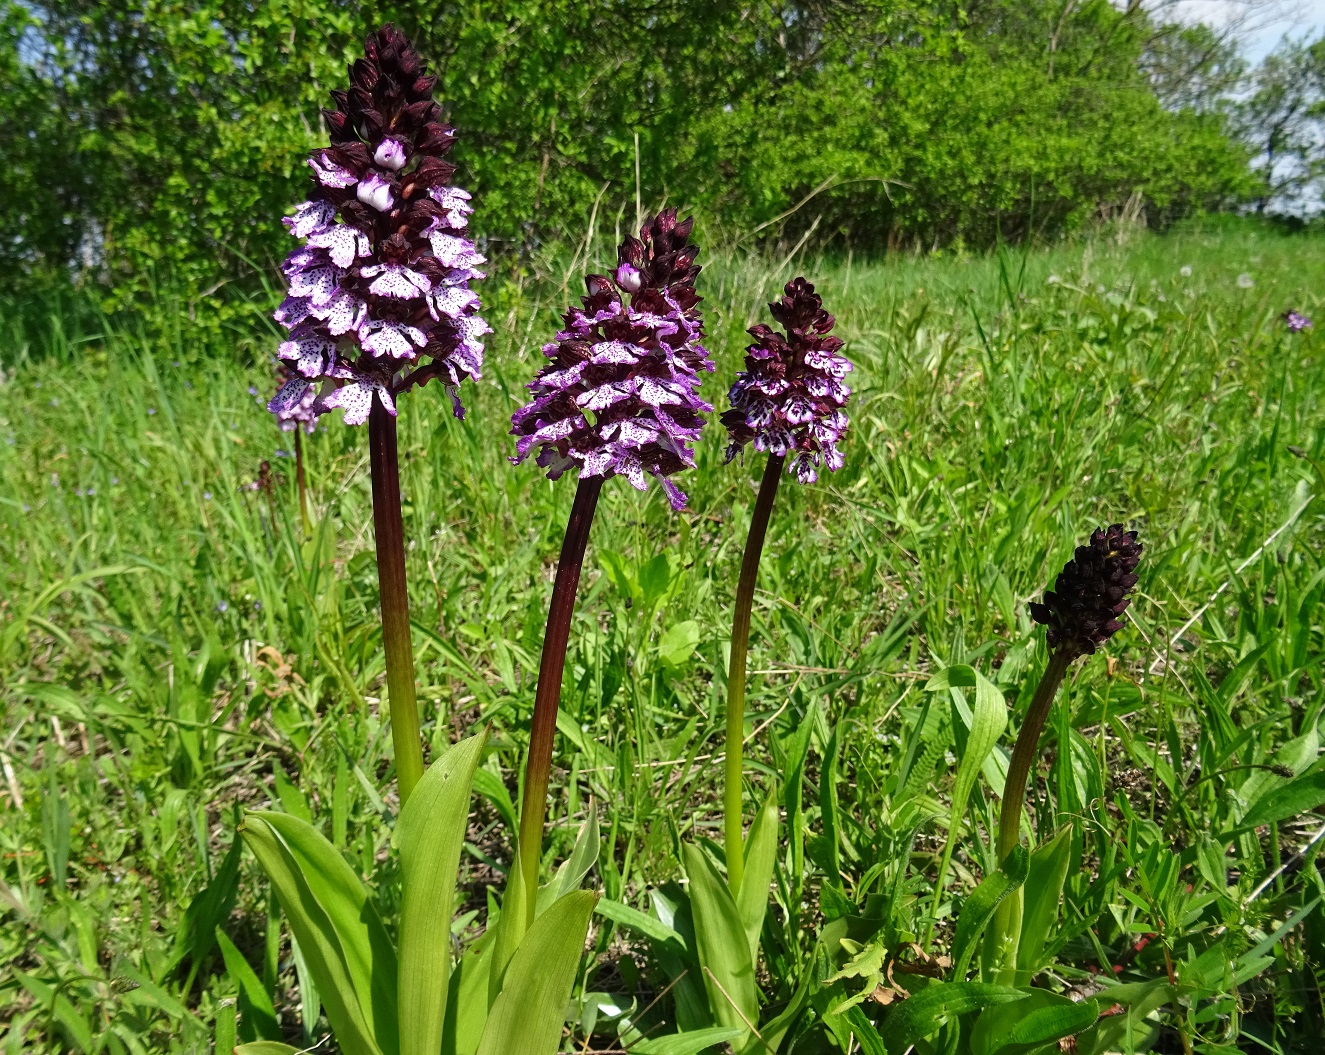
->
<box><xmin>722</xmin><ymin>455</ymin><xmax>787</xmax><ymax>896</ymax></box>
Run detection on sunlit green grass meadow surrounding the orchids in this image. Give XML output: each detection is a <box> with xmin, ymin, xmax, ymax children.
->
<box><xmin>0</xmin><ymin>218</ymin><xmax>1325</xmax><ymax>1055</ymax></box>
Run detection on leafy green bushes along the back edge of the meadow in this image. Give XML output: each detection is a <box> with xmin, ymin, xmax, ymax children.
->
<box><xmin>0</xmin><ymin>0</ymin><xmax>1261</xmax><ymax>304</ymax></box>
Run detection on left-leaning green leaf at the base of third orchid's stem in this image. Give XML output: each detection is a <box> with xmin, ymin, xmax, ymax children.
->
<box><xmin>681</xmin><ymin>843</ymin><xmax>759</xmax><ymax>1048</ymax></box>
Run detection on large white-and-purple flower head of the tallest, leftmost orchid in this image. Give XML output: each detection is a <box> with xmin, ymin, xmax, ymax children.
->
<box><xmin>268</xmin><ymin>25</ymin><xmax>492</xmax><ymax>424</ymax></box>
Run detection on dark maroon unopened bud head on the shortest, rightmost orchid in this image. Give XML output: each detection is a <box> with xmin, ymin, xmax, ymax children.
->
<box><xmin>1031</xmin><ymin>524</ymin><xmax>1142</xmax><ymax>657</ymax></box>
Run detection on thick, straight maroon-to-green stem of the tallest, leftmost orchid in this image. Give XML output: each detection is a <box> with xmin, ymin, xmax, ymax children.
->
<box><xmin>368</xmin><ymin>399</ymin><xmax>423</xmax><ymax>806</ymax></box>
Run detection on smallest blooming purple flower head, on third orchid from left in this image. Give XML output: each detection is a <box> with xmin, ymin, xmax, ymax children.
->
<box><xmin>722</xmin><ymin>278</ymin><xmax>852</xmax><ymax>484</ymax></box>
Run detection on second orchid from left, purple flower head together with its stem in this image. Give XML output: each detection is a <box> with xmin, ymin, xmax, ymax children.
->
<box><xmin>510</xmin><ymin>209</ymin><xmax>713</xmax><ymax>925</ymax></box>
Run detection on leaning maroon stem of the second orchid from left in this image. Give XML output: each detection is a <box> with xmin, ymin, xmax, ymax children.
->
<box><xmin>519</xmin><ymin>476</ymin><xmax>603</xmax><ymax>926</ymax></box>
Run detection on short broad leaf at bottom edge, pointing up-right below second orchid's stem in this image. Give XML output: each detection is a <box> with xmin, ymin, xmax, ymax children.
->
<box><xmin>478</xmin><ymin>891</ymin><xmax>598</xmax><ymax>1055</ymax></box>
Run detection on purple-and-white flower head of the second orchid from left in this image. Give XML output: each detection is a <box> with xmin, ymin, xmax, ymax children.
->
<box><xmin>511</xmin><ymin>209</ymin><xmax>713</xmax><ymax>509</ymax></box>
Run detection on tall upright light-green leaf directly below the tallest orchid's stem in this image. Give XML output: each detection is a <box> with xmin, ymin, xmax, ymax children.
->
<box><xmin>392</xmin><ymin>733</ymin><xmax>488</xmax><ymax>1055</ymax></box>
